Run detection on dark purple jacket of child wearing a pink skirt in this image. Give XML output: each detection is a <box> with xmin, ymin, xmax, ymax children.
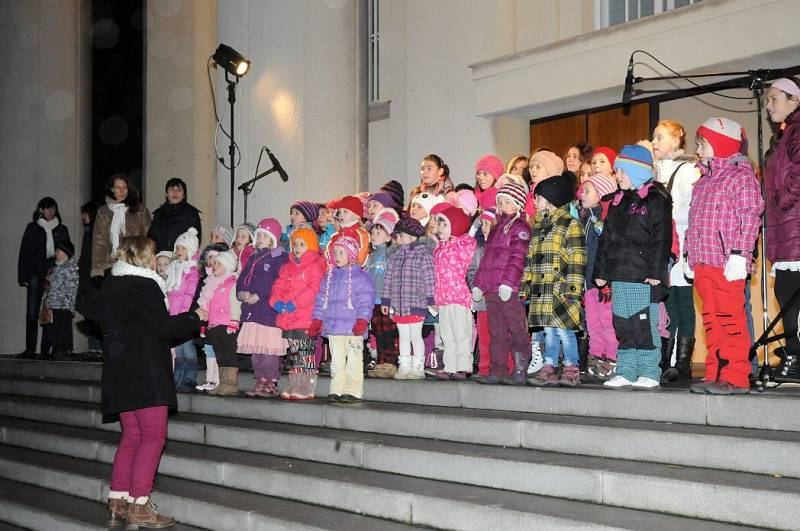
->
<box><xmin>236</xmin><ymin>246</ymin><xmax>289</xmax><ymax>326</ymax></box>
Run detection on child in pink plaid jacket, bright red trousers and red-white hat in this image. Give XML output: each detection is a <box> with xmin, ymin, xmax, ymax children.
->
<box><xmin>686</xmin><ymin>118</ymin><xmax>764</xmax><ymax>395</ymax></box>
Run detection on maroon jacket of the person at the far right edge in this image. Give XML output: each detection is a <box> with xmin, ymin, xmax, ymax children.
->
<box><xmin>764</xmin><ymin>111</ymin><xmax>800</xmax><ymax>263</ymax></box>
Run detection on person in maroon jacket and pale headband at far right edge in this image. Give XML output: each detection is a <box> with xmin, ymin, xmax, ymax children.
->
<box><xmin>764</xmin><ymin>78</ymin><xmax>800</xmax><ymax>378</ymax></box>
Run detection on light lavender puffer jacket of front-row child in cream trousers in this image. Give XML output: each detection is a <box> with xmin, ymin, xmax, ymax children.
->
<box><xmin>312</xmin><ymin>264</ymin><xmax>375</xmax><ymax>337</ymax></box>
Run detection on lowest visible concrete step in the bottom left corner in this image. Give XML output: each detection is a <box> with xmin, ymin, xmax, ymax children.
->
<box><xmin>0</xmin><ymin>479</ymin><xmax>202</xmax><ymax>531</ymax></box>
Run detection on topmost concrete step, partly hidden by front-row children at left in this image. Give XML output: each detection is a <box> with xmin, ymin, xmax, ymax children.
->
<box><xmin>0</xmin><ymin>359</ymin><xmax>800</xmax><ymax>431</ymax></box>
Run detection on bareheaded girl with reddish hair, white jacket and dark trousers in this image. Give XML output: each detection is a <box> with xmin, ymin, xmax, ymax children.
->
<box><xmin>652</xmin><ymin>120</ymin><xmax>700</xmax><ymax>383</ymax></box>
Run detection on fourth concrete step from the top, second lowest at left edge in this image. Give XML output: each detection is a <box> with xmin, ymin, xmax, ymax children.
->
<box><xmin>0</xmin><ymin>446</ymin><xmax>424</xmax><ymax>531</ymax></box>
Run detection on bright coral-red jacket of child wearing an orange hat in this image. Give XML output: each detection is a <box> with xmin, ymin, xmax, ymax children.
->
<box><xmin>269</xmin><ymin>251</ymin><xmax>326</xmax><ymax>330</ymax></box>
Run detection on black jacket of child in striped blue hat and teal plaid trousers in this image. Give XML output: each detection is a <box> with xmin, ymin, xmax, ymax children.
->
<box><xmin>592</xmin><ymin>184</ymin><xmax>672</xmax><ymax>287</ymax></box>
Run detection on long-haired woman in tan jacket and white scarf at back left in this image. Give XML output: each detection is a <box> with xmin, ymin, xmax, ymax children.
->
<box><xmin>91</xmin><ymin>173</ymin><xmax>151</xmax><ymax>279</ymax></box>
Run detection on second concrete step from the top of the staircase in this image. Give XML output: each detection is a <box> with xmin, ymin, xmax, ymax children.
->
<box><xmin>0</xmin><ymin>382</ymin><xmax>800</xmax><ymax>478</ymax></box>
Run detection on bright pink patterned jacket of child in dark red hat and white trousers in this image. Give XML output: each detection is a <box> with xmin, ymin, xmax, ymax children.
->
<box><xmin>433</xmin><ymin>234</ymin><xmax>478</xmax><ymax>308</ymax></box>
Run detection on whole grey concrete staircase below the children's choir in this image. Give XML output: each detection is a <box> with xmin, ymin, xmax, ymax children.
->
<box><xmin>0</xmin><ymin>358</ymin><xmax>800</xmax><ymax>530</ymax></box>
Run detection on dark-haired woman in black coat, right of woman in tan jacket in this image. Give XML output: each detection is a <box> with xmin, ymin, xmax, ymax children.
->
<box><xmin>147</xmin><ymin>177</ymin><xmax>203</xmax><ymax>253</ymax></box>
